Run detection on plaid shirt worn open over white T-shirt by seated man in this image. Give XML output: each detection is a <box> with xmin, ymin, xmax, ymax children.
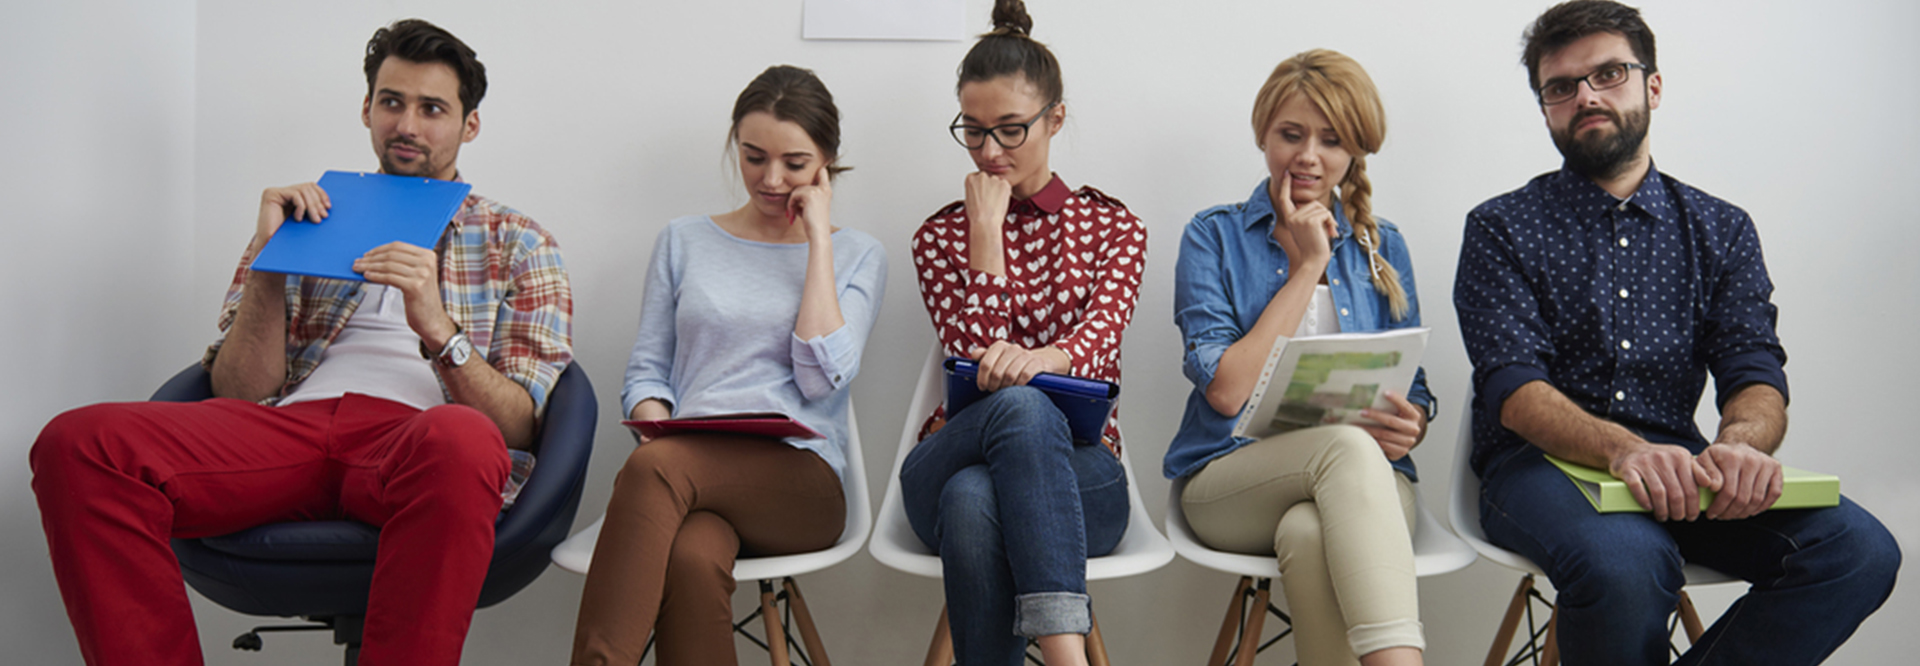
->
<box><xmin>202</xmin><ymin>194</ymin><xmax>574</xmax><ymax>415</ymax></box>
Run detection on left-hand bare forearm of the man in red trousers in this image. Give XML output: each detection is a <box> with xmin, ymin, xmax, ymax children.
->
<box><xmin>211</xmin><ymin>273</ymin><xmax>286</xmax><ymax>403</ymax></box>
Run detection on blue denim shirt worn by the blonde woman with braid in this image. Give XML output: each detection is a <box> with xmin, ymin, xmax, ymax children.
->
<box><xmin>1162</xmin><ymin>180</ymin><xmax>1434</xmax><ymax>480</ymax></box>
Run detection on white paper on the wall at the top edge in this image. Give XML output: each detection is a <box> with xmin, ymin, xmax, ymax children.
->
<box><xmin>801</xmin><ymin>0</ymin><xmax>966</xmax><ymax>42</ymax></box>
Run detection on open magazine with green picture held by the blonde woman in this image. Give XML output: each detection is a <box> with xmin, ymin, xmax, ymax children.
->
<box><xmin>1233</xmin><ymin>328</ymin><xmax>1430</xmax><ymax>440</ymax></box>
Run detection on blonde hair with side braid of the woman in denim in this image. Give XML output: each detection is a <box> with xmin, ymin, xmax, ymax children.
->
<box><xmin>1254</xmin><ymin>48</ymin><xmax>1411</xmax><ymax>319</ymax></box>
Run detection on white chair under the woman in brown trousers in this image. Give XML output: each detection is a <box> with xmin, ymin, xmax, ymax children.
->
<box><xmin>553</xmin><ymin>405</ymin><xmax>874</xmax><ymax>666</ymax></box>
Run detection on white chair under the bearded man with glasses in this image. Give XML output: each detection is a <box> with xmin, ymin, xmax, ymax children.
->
<box><xmin>1448</xmin><ymin>406</ymin><xmax>1738</xmax><ymax>666</ymax></box>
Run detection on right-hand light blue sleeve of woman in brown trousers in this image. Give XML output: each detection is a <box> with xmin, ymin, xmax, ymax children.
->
<box><xmin>789</xmin><ymin>244</ymin><xmax>887</xmax><ymax>401</ymax></box>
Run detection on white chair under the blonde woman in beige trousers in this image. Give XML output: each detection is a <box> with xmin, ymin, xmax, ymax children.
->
<box><xmin>1167</xmin><ymin>451</ymin><xmax>1475</xmax><ymax>666</ymax></box>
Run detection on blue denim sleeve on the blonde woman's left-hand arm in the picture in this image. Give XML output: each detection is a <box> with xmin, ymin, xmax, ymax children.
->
<box><xmin>1173</xmin><ymin>215</ymin><xmax>1246</xmax><ymax>390</ymax></box>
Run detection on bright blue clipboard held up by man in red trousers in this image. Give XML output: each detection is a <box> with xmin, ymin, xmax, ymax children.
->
<box><xmin>253</xmin><ymin>171</ymin><xmax>474</xmax><ymax>280</ymax></box>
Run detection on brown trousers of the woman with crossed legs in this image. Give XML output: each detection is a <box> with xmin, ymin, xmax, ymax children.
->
<box><xmin>572</xmin><ymin>434</ymin><xmax>847</xmax><ymax>666</ymax></box>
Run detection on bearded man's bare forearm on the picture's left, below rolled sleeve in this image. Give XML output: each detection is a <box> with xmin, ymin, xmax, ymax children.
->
<box><xmin>1500</xmin><ymin>382</ymin><xmax>1647</xmax><ymax>470</ymax></box>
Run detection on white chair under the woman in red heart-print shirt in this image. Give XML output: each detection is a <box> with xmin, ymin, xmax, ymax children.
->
<box><xmin>868</xmin><ymin>347</ymin><xmax>1173</xmax><ymax>666</ymax></box>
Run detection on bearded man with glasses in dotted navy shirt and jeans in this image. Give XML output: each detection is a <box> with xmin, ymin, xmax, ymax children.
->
<box><xmin>1453</xmin><ymin>0</ymin><xmax>1901</xmax><ymax>666</ymax></box>
